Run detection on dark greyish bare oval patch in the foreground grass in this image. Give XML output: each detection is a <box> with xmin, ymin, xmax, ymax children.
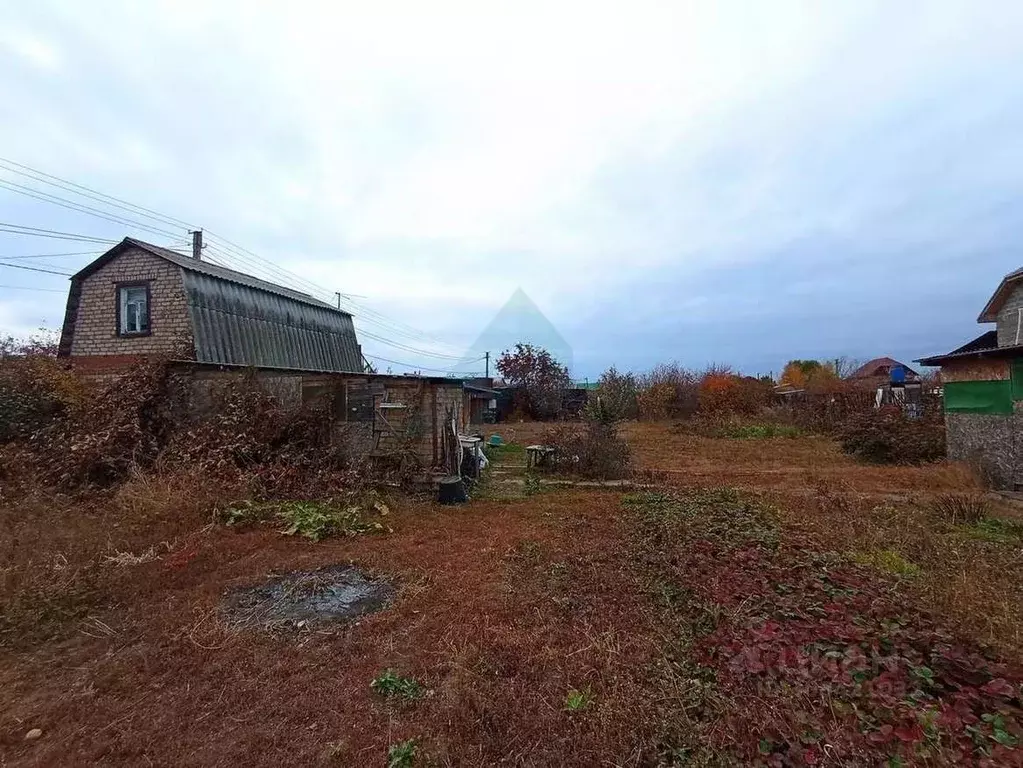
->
<box><xmin>221</xmin><ymin>566</ymin><xmax>395</xmax><ymax>629</ymax></box>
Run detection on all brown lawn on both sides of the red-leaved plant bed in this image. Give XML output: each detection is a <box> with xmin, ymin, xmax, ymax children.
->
<box><xmin>0</xmin><ymin>423</ymin><xmax>1023</xmax><ymax>766</ymax></box>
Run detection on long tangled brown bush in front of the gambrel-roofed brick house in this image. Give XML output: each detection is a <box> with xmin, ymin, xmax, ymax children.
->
<box><xmin>0</xmin><ymin>356</ymin><xmax>364</xmax><ymax>498</ymax></box>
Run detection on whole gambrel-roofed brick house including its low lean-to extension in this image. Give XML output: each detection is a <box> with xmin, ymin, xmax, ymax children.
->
<box><xmin>57</xmin><ymin>237</ymin><xmax>470</xmax><ymax>468</ymax></box>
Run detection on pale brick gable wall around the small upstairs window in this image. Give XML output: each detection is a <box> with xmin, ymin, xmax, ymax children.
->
<box><xmin>71</xmin><ymin>249</ymin><xmax>192</xmax><ymax>362</ymax></box>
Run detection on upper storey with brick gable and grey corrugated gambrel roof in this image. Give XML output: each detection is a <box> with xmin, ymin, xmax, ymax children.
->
<box><xmin>58</xmin><ymin>237</ymin><xmax>363</xmax><ymax>372</ymax></box>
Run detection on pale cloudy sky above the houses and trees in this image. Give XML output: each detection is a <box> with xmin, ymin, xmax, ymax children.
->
<box><xmin>0</xmin><ymin>0</ymin><xmax>1023</xmax><ymax>377</ymax></box>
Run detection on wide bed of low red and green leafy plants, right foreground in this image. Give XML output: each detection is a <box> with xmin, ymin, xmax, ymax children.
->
<box><xmin>628</xmin><ymin>492</ymin><xmax>1023</xmax><ymax>766</ymax></box>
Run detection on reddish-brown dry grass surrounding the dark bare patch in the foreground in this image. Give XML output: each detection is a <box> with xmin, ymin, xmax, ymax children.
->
<box><xmin>0</xmin><ymin>494</ymin><xmax>653</xmax><ymax>765</ymax></box>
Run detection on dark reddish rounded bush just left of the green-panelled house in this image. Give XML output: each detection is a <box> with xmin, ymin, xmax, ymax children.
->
<box><xmin>840</xmin><ymin>410</ymin><xmax>945</xmax><ymax>464</ymax></box>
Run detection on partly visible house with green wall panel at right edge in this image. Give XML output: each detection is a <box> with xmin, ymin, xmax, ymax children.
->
<box><xmin>917</xmin><ymin>269</ymin><xmax>1023</xmax><ymax>489</ymax></box>
